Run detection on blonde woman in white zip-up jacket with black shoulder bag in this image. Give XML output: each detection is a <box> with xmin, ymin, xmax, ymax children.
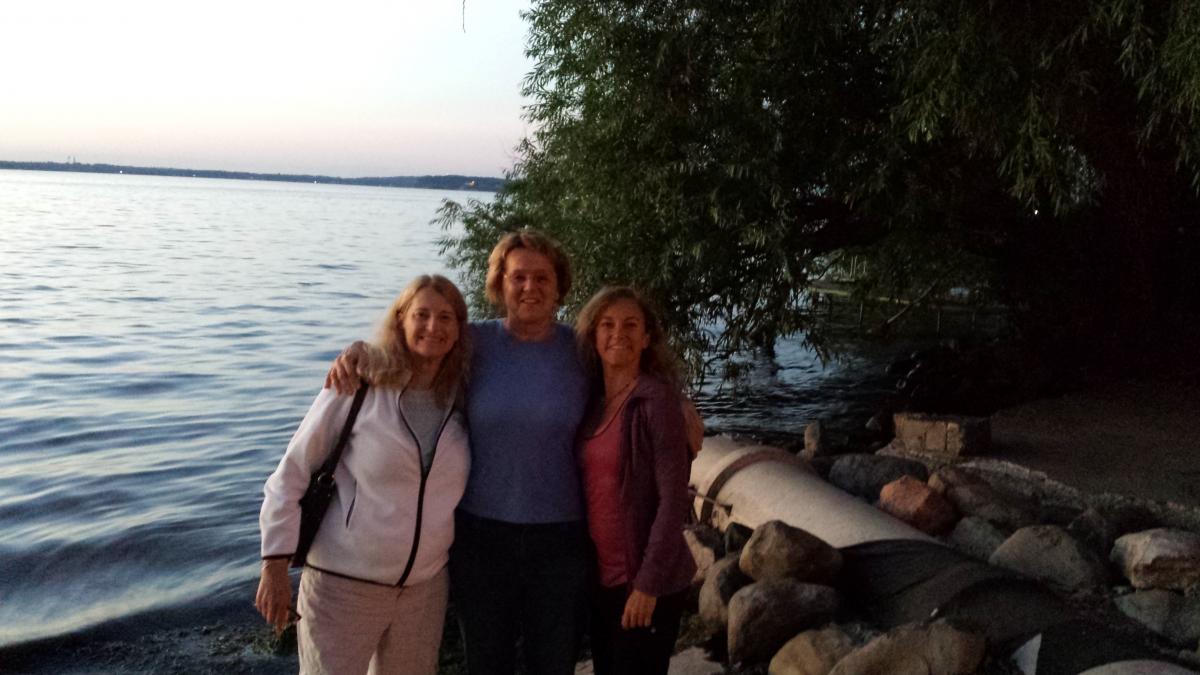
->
<box><xmin>256</xmin><ymin>275</ymin><xmax>470</xmax><ymax>674</ymax></box>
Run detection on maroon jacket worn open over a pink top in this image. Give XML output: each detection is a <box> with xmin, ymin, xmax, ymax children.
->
<box><xmin>588</xmin><ymin>374</ymin><xmax>696</xmax><ymax>597</ymax></box>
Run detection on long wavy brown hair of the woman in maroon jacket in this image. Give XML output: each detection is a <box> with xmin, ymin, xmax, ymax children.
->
<box><xmin>575</xmin><ymin>286</ymin><xmax>680</xmax><ymax>389</ymax></box>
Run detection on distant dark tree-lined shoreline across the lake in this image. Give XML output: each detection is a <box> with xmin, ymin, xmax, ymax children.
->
<box><xmin>0</xmin><ymin>160</ymin><xmax>505</xmax><ymax>192</ymax></box>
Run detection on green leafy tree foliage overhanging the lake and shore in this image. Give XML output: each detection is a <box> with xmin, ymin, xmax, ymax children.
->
<box><xmin>440</xmin><ymin>0</ymin><xmax>1200</xmax><ymax>379</ymax></box>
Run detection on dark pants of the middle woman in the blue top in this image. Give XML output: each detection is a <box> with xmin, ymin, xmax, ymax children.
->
<box><xmin>450</xmin><ymin>512</ymin><xmax>589</xmax><ymax>675</ymax></box>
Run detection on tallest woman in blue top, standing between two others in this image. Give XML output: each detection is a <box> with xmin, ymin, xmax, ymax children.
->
<box><xmin>330</xmin><ymin>231</ymin><xmax>589</xmax><ymax>675</ymax></box>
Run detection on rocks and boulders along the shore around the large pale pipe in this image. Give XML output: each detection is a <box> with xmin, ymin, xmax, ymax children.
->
<box><xmin>688</xmin><ymin>413</ymin><xmax>1200</xmax><ymax>675</ymax></box>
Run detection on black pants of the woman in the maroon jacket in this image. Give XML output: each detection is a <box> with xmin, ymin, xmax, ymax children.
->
<box><xmin>592</xmin><ymin>586</ymin><xmax>686</xmax><ymax>675</ymax></box>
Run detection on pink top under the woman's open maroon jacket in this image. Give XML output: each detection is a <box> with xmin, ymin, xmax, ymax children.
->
<box><xmin>583</xmin><ymin>411</ymin><xmax>629</xmax><ymax>586</ymax></box>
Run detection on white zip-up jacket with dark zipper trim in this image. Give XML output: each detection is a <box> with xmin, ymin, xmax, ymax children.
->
<box><xmin>258</xmin><ymin>387</ymin><xmax>470</xmax><ymax>586</ymax></box>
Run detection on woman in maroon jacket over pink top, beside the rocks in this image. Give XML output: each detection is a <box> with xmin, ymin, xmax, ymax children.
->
<box><xmin>575</xmin><ymin>287</ymin><xmax>696</xmax><ymax>675</ymax></box>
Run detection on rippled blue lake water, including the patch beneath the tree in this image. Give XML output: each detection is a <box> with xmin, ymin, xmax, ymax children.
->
<box><xmin>0</xmin><ymin>171</ymin><xmax>886</xmax><ymax>647</ymax></box>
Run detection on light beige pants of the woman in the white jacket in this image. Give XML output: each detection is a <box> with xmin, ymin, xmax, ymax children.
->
<box><xmin>296</xmin><ymin>567</ymin><xmax>450</xmax><ymax>675</ymax></box>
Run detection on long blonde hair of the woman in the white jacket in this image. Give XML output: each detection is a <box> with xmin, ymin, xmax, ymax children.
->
<box><xmin>360</xmin><ymin>274</ymin><xmax>470</xmax><ymax>406</ymax></box>
